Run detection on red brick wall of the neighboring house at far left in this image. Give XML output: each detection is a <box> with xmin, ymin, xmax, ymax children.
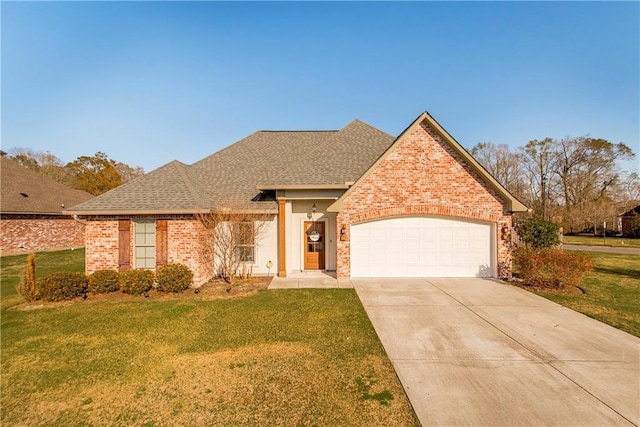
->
<box><xmin>0</xmin><ymin>215</ymin><xmax>85</xmax><ymax>255</ymax></box>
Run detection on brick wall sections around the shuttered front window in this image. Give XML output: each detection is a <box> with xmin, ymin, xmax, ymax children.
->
<box><xmin>86</xmin><ymin>218</ymin><xmax>212</xmax><ymax>286</ymax></box>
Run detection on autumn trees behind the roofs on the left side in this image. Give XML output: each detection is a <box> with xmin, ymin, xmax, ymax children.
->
<box><xmin>6</xmin><ymin>147</ymin><xmax>144</xmax><ymax>196</ymax></box>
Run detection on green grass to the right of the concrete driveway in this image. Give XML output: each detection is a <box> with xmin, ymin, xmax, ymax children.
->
<box><xmin>541</xmin><ymin>252</ymin><xmax>640</xmax><ymax>337</ymax></box>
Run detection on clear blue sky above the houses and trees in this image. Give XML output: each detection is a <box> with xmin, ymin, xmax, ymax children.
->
<box><xmin>1</xmin><ymin>1</ymin><xmax>640</xmax><ymax>171</ymax></box>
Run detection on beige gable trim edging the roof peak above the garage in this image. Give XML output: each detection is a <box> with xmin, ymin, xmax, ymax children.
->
<box><xmin>328</xmin><ymin>111</ymin><xmax>529</xmax><ymax>212</ymax></box>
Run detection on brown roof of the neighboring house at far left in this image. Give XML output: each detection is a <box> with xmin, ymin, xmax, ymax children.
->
<box><xmin>0</xmin><ymin>155</ymin><xmax>94</xmax><ymax>215</ymax></box>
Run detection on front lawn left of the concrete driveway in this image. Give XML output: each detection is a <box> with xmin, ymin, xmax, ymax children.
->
<box><xmin>0</xmin><ymin>252</ymin><xmax>418</xmax><ymax>426</ymax></box>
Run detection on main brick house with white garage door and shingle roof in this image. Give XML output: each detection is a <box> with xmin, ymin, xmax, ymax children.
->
<box><xmin>68</xmin><ymin>113</ymin><xmax>527</xmax><ymax>284</ymax></box>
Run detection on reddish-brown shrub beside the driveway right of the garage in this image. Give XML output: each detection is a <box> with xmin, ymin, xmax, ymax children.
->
<box><xmin>513</xmin><ymin>248</ymin><xmax>593</xmax><ymax>289</ymax></box>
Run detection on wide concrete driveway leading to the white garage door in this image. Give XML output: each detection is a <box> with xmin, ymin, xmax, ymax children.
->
<box><xmin>351</xmin><ymin>279</ymin><xmax>640</xmax><ymax>426</ymax></box>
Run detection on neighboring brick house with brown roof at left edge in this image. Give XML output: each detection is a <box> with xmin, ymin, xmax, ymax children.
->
<box><xmin>0</xmin><ymin>155</ymin><xmax>94</xmax><ymax>255</ymax></box>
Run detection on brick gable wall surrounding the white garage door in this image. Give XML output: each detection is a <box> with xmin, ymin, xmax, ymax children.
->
<box><xmin>336</xmin><ymin>125</ymin><xmax>512</xmax><ymax>277</ymax></box>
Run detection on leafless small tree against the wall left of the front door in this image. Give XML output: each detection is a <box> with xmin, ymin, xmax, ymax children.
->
<box><xmin>197</xmin><ymin>209</ymin><xmax>273</xmax><ymax>290</ymax></box>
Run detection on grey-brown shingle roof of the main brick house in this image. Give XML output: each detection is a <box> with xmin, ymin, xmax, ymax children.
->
<box><xmin>65</xmin><ymin>120</ymin><xmax>394</xmax><ymax>214</ymax></box>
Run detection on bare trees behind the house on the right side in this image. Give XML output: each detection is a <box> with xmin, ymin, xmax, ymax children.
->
<box><xmin>470</xmin><ymin>136</ymin><xmax>640</xmax><ymax>233</ymax></box>
